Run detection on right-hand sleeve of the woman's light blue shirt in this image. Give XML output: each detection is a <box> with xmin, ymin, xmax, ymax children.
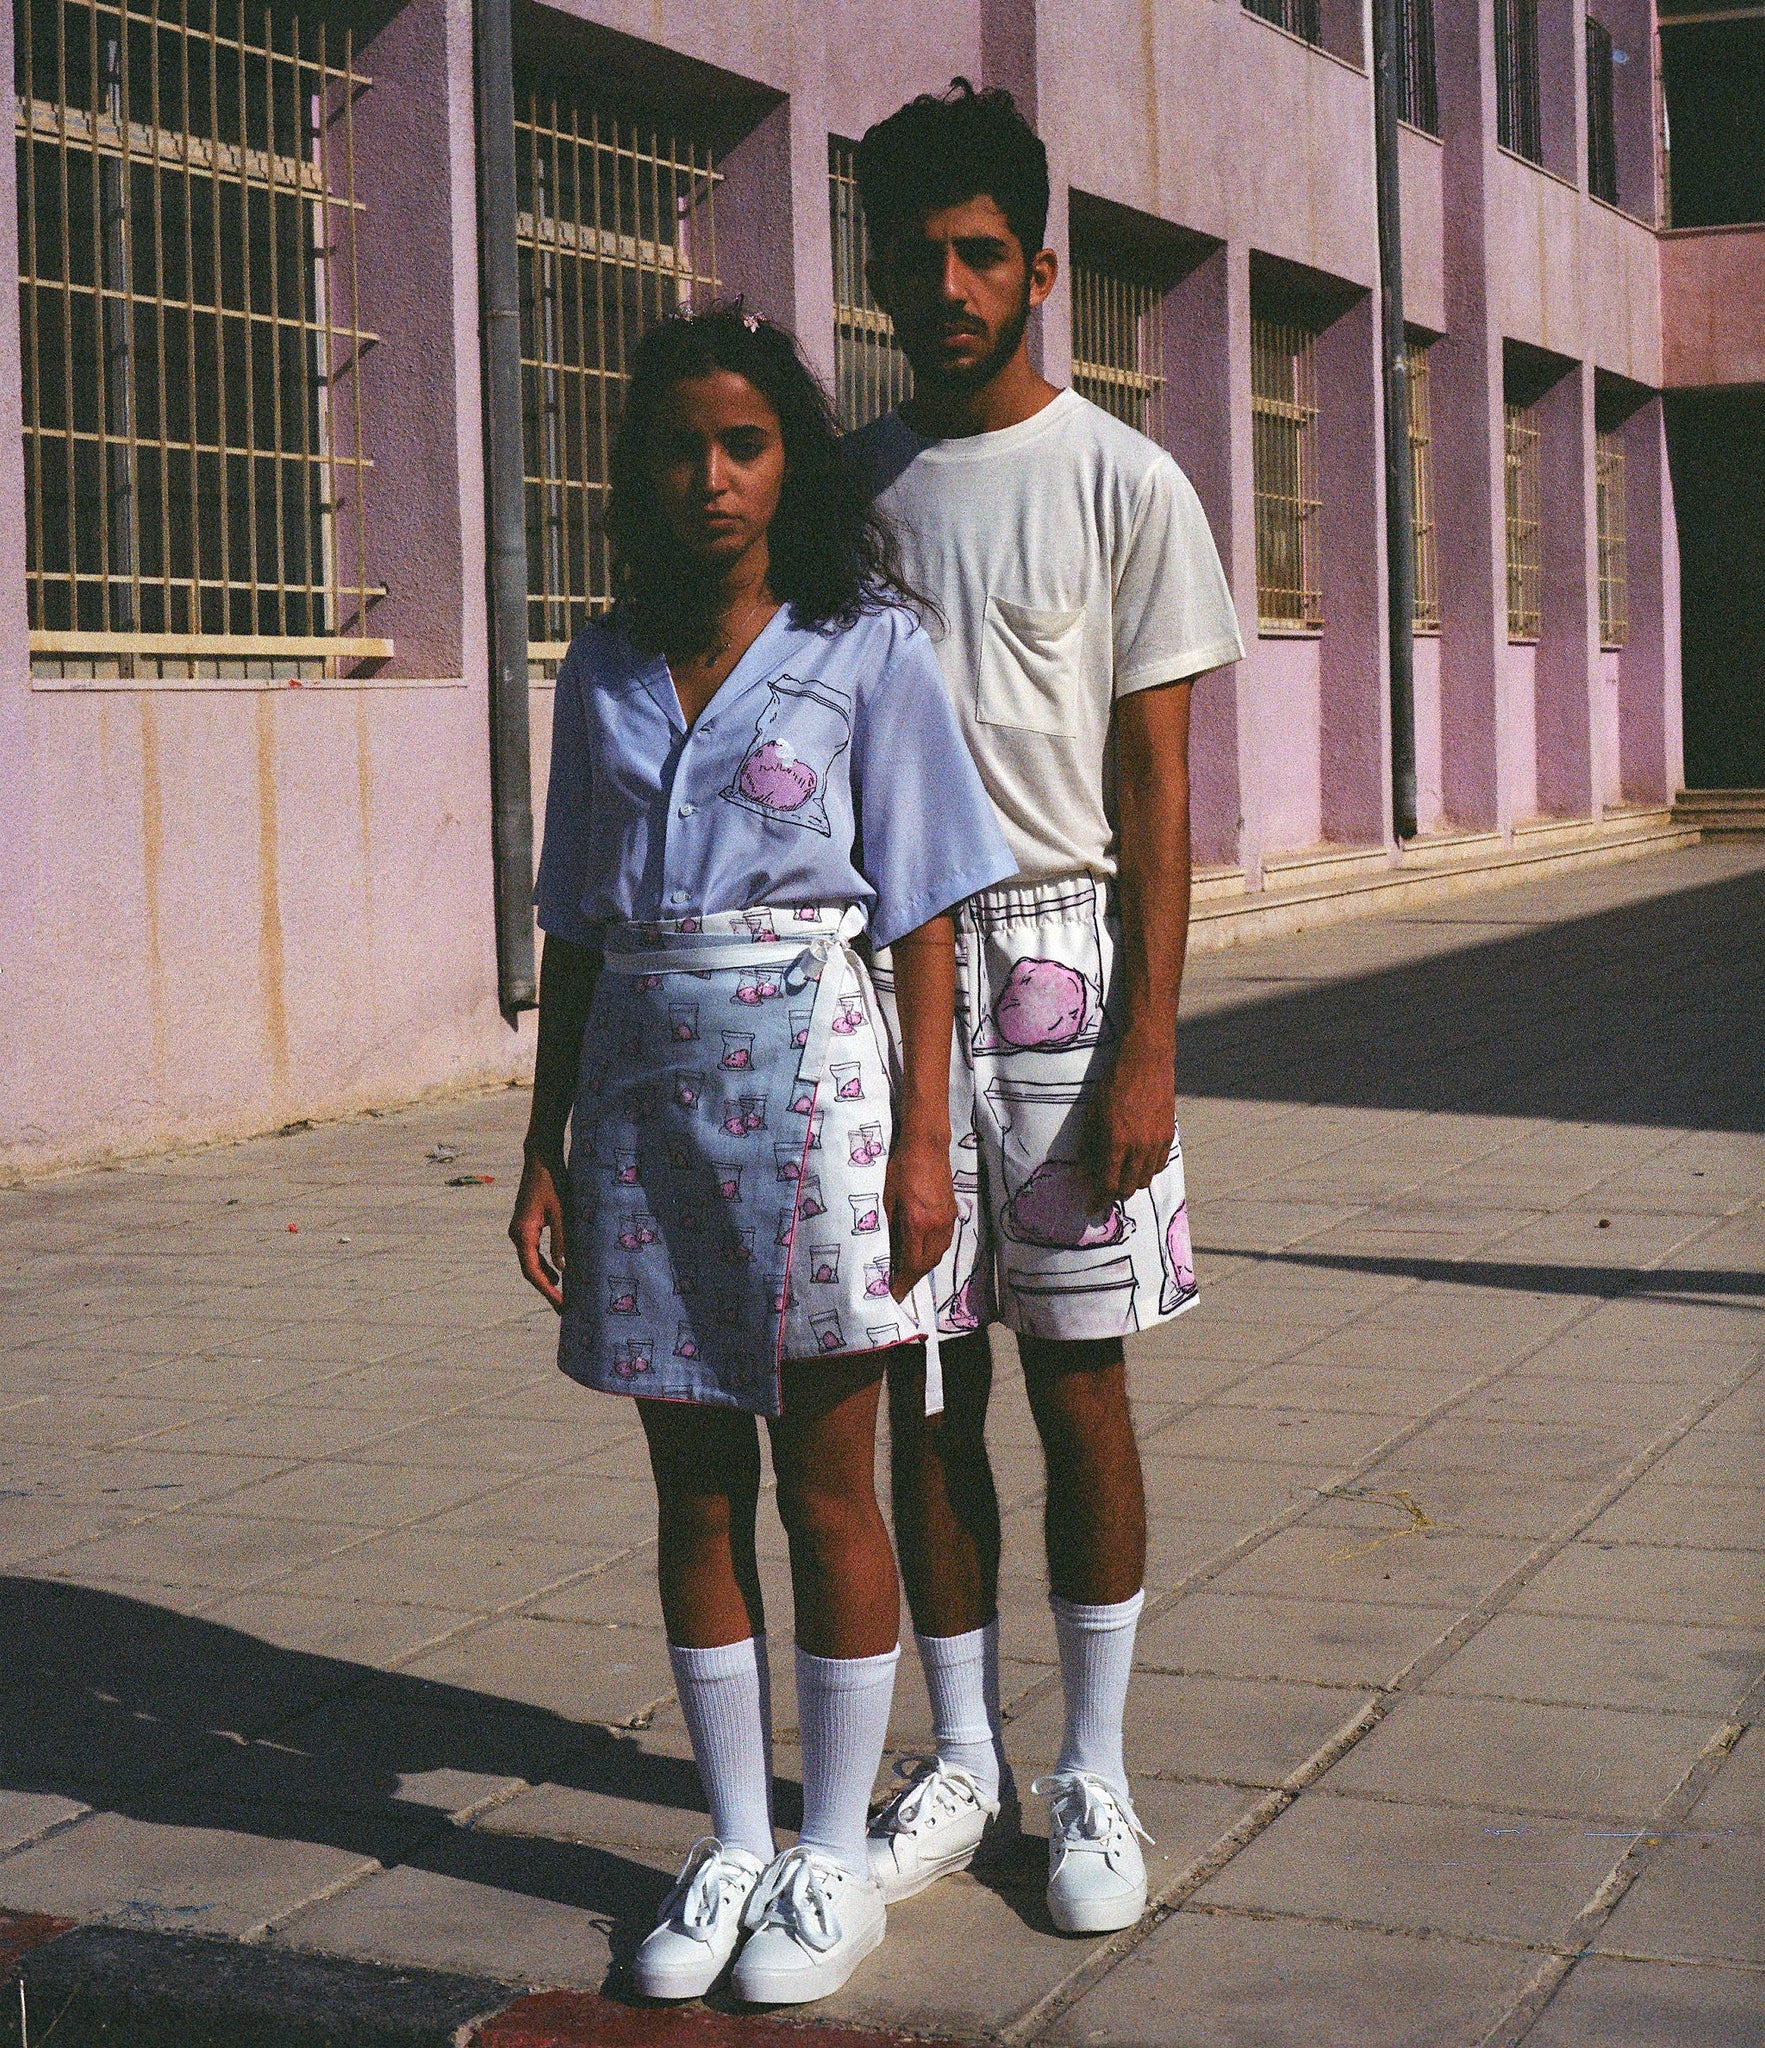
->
<box><xmin>852</xmin><ymin>621</ymin><xmax>1018</xmax><ymax>946</ymax></box>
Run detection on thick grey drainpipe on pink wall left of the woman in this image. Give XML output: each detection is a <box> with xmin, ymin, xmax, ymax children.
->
<box><xmin>473</xmin><ymin>0</ymin><xmax>539</xmax><ymax>1024</ymax></box>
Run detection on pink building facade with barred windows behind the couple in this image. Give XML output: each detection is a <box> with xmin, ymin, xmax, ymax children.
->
<box><xmin>0</xmin><ymin>0</ymin><xmax>1687</xmax><ymax>1174</ymax></box>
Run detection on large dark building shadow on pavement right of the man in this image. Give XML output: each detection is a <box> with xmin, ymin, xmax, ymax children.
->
<box><xmin>1177</xmin><ymin>868</ymin><xmax>1765</xmax><ymax>1133</ymax></box>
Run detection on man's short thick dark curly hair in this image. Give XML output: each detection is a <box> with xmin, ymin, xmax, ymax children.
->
<box><xmin>858</xmin><ymin>78</ymin><xmax>1048</xmax><ymax>258</ymax></box>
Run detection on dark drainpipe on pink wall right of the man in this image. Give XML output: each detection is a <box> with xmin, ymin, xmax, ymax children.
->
<box><xmin>1372</xmin><ymin>0</ymin><xmax>1415</xmax><ymax>840</ymax></box>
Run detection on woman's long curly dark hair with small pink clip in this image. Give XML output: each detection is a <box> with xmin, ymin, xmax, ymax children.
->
<box><xmin>602</xmin><ymin>299</ymin><xmax>932</xmax><ymax>651</ymax></box>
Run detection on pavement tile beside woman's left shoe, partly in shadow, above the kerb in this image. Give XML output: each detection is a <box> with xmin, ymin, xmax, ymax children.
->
<box><xmin>276</xmin><ymin>1829</ymin><xmax>642</xmax><ymax>1991</ymax></box>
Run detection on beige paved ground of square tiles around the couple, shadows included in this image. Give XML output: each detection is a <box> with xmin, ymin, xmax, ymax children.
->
<box><xmin>0</xmin><ymin>846</ymin><xmax>1765</xmax><ymax>2048</ymax></box>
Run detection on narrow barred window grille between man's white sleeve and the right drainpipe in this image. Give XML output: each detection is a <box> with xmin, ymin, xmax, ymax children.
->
<box><xmin>1251</xmin><ymin>317</ymin><xmax>1323</xmax><ymax>629</ymax></box>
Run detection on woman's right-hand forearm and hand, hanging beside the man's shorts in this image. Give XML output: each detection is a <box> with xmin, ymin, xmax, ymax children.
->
<box><xmin>883</xmin><ymin>913</ymin><xmax>956</xmax><ymax>1300</ymax></box>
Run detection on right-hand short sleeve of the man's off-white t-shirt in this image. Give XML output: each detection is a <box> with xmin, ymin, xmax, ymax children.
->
<box><xmin>1114</xmin><ymin>459</ymin><xmax>1245</xmax><ymax>696</ymax></box>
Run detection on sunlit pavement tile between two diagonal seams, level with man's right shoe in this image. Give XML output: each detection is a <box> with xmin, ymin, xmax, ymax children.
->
<box><xmin>1196</xmin><ymin>1780</ymin><xmax>1624</xmax><ymax>1942</ymax></box>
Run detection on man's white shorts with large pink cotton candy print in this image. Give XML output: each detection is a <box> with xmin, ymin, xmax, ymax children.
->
<box><xmin>876</xmin><ymin>877</ymin><xmax>1196</xmax><ymax>1339</ymax></box>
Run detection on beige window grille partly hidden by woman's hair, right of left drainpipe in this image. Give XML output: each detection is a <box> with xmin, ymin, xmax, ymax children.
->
<box><xmin>514</xmin><ymin>90</ymin><xmax>719</xmax><ymax>655</ymax></box>
